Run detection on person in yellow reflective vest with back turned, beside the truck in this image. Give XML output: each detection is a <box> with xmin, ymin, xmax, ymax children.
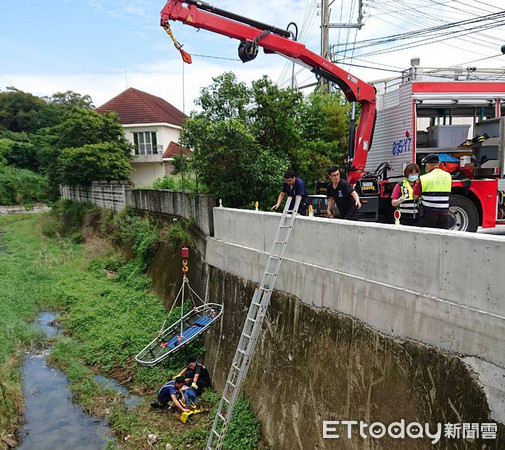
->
<box><xmin>414</xmin><ymin>153</ymin><xmax>452</xmax><ymax>229</ymax></box>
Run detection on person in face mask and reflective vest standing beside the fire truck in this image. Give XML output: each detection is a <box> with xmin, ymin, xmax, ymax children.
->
<box><xmin>391</xmin><ymin>163</ymin><xmax>421</xmax><ymax>226</ymax></box>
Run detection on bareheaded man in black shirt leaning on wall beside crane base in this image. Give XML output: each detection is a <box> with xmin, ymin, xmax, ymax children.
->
<box><xmin>326</xmin><ymin>166</ymin><xmax>361</xmax><ymax>220</ymax></box>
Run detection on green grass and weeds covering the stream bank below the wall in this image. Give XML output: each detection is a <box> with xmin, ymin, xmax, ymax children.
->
<box><xmin>0</xmin><ymin>212</ymin><xmax>259</xmax><ymax>449</ymax></box>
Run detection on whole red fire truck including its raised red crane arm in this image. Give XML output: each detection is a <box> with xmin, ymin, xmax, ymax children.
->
<box><xmin>161</xmin><ymin>0</ymin><xmax>505</xmax><ymax>231</ymax></box>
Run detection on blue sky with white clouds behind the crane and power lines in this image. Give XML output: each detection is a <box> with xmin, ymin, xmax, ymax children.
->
<box><xmin>0</xmin><ymin>0</ymin><xmax>505</xmax><ymax>114</ymax></box>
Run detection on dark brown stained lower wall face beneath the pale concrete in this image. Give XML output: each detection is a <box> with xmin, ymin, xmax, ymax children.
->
<box><xmin>200</xmin><ymin>268</ymin><xmax>505</xmax><ymax>449</ymax></box>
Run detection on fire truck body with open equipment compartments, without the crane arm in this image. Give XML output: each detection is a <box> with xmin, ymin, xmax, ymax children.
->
<box><xmin>366</xmin><ymin>66</ymin><xmax>505</xmax><ymax>231</ymax></box>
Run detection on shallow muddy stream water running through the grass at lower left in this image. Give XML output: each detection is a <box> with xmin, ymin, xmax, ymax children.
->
<box><xmin>18</xmin><ymin>313</ymin><xmax>113</xmax><ymax>450</ymax></box>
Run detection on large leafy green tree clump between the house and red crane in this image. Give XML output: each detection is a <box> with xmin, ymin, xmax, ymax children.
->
<box><xmin>180</xmin><ymin>73</ymin><xmax>349</xmax><ymax>206</ymax></box>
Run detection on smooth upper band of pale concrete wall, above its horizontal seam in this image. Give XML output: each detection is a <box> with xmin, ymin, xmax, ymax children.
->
<box><xmin>214</xmin><ymin>208</ymin><xmax>505</xmax><ymax>315</ymax></box>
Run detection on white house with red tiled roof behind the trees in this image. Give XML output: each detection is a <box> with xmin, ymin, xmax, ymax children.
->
<box><xmin>96</xmin><ymin>88</ymin><xmax>192</xmax><ymax>187</ymax></box>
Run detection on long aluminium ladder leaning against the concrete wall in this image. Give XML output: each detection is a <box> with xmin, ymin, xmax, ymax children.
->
<box><xmin>206</xmin><ymin>195</ymin><xmax>301</xmax><ymax>450</ymax></box>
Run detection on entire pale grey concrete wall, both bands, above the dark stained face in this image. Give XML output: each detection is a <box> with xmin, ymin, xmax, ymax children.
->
<box><xmin>207</xmin><ymin>208</ymin><xmax>505</xmax><ymax>367</ymax></box>
